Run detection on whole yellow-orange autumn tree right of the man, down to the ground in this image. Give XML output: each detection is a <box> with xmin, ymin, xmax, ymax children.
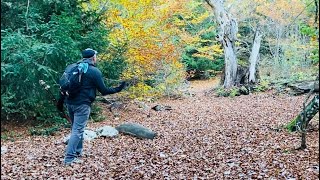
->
<box><xmin>103</xmin><ymin>0</ymin><xmax>185</xmax><ymax>98</ymax></box>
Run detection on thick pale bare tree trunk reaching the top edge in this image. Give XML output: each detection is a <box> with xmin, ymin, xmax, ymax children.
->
<box><xmin>206</xmin><ymin>0</ymin><xmax>238</xmax><ymax>88</ymax></box>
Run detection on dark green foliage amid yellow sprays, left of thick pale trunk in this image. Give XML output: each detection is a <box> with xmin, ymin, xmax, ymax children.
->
<box><xmin>179</xmin><ymin>2</ymin><xmax>224</xmax><ymax>79</ymax></box>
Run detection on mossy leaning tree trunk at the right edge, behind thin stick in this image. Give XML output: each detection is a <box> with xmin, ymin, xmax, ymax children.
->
<box><xmin>287</xmin><ymin>94</ymin><xmax>319</xmax><ymax>131</ymax></box>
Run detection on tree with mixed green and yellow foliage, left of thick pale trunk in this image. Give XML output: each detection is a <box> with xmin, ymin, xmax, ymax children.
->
<box><xmin>172</xmin><ymin>0</ymin><xmax>224</xmax><ymax>79</ymax></box>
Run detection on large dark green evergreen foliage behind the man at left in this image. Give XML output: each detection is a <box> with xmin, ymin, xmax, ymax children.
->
<box><xmin>1</xmin><ymin>1</ymin><xmax>108</xmax><ymax>123</ymax></box>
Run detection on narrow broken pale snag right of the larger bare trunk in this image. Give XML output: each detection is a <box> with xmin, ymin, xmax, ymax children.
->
<box><xmin>248</xmin><ymin>29</ymin><xmax>262</xmax><ymax>83</ymax></box>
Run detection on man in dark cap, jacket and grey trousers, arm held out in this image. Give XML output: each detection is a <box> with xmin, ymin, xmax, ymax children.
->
<box><xmin>57</xmin><ymin>48</ymin><xmax>126</xmax><ymax>165</ymax></box>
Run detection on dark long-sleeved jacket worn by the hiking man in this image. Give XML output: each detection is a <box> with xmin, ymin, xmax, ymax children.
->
<box><xmin>62</xmin><ymin>59</ymin><xmax>125</xmax><ymax>106</ymax></box>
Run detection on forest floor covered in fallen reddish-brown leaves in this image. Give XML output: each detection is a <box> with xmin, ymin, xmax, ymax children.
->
<box><xmin>1</xmin><ymin>80</ymin><xmax>319</xmax><ymax>179</ymax></box>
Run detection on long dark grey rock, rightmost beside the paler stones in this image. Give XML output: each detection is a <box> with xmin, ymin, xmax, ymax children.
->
<box><xmin>116</xmin><ymin>123</ymin><xmax>157</xmax><ymax>139</ymax></box>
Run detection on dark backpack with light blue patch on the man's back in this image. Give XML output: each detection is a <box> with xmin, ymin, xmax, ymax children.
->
<box><xmin>59</xmin><ymin>62</ymin><xmax>89</xmax><ymax>99</ymax></box>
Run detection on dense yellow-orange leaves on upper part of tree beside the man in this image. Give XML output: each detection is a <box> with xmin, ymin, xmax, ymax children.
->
<box><xmin>107</xmin><ymin>0</ymin><xmax>185</xmax><ymax>79</ymax></box>
